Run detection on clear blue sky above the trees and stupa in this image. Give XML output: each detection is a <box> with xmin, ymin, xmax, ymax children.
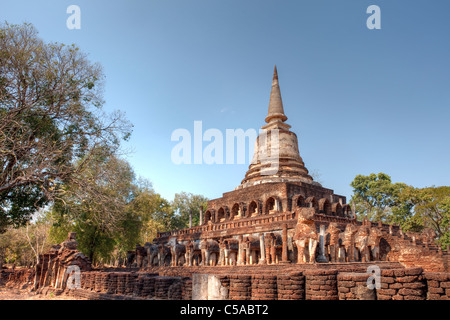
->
<box><xmin>0</xmin><ymin>0</ymin><xmax>450</xmax><ymax>200</ymax></box>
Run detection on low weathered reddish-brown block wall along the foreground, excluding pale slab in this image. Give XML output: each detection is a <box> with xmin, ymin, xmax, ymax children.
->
<box><xmin>0</xmin><ymin>268</ymin><xmax>450</xmax><ymax>300</ymax></box>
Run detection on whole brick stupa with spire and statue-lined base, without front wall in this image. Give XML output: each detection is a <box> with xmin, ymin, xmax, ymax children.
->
<box><xmin>147</xmin><ymin>67</ymin><xmax>449</xmax><ymax>271</ymax></box>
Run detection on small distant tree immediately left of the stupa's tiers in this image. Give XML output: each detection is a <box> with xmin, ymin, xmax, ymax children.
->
<box><xmin>172</xmin><ymin>192</ymin><xmax>208</xmax><ymax>229</ymax></box>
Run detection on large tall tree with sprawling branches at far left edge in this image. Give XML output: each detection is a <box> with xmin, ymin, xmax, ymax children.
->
<box><xmin>0</xmin><ymin>24</ymin><xmax>130</xmax><ymax>228</ymax></box>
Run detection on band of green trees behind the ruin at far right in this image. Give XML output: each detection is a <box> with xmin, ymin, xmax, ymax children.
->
<box><xmin>351</xmin><ymin>173</ymin><xmax>450</xmax><ymax>249</ymax></box>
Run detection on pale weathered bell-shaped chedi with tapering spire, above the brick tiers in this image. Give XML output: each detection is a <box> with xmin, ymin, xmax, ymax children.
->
<box><xmin>237</xmin><ymin>66</ymin><xmax>320</xmax><ymax>189</ymax></box>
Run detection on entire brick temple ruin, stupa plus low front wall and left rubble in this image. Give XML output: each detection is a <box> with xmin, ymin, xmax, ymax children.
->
<box><xmin>4</xmin><ymin>68</ymin><xmax>450</xmax><ymax>300</ymax></box>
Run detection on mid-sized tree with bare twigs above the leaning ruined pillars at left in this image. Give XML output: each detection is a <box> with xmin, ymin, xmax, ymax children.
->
<box><xmin>53</xmin><ymin>156</ymin><xmax>134</xmax><ymax>262</ymax></box>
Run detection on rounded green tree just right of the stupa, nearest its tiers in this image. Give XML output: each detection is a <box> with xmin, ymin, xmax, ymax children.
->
<box><xmin>350</xmin><ymin>173</ymin><xmax>407</xmax><ymax>221</ymax></box>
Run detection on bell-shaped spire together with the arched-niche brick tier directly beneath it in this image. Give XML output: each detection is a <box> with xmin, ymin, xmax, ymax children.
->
<box><xmin>204</xmin><ymin>66</ymin><xmax>353</xmax><ymax>223</ymax></box>
